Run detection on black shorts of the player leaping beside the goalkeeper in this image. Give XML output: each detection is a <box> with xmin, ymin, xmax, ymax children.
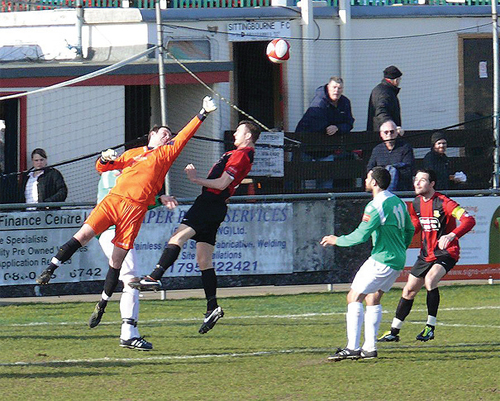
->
<box><xmin>181</xmin><ymin>193</ymin><xmax>227</xmax><ymax>245</ymax></box>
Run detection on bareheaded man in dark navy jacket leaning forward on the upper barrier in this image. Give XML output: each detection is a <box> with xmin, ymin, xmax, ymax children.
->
<box><xmin>295</xmin><ymin>77</ymin><xmax>354</xmax><ymax>160</ymax></box>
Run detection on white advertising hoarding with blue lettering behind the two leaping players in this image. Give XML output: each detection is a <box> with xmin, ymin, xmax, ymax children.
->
<box><xmin>0</xmin><ymin>203</ymin><xmax>294</xmax><ymax>285</ymax></box>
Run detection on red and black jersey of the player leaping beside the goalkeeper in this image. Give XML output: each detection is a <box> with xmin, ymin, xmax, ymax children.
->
<box><xmin>203</xmin><ymin>147</ymin><xmax>255</xmax><ymax>200</ymax></box>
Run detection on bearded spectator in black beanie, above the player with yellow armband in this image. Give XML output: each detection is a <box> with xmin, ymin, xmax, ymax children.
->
<box><xmin>424</xmin><ymin>131</ymin><xmax>467</xmax><ymax>190</ymax></box>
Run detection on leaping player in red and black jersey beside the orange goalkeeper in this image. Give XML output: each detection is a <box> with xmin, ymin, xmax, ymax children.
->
<box><xmin>129</xmin><ymin>120</ymin><xmax>260</xmax><ymax>334</ymax></box>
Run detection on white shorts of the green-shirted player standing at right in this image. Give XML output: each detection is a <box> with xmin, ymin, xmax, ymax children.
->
<box><xmin>351</xmin><ymin>258</ymin><xmax>401</xmax><ymax>294</ymax></box>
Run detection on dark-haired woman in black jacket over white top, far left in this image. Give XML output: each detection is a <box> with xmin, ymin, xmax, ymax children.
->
<box><xmin>20</xmin><ymin>148</ymin><xmax>68</xmax><ymax>203</ymax></box>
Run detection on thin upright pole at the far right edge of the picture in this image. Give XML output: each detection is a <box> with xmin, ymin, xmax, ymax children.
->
<box><xmin>491</xmin><ymin>0</ymin><xmax>500</xmax><ymax>189</ymax></box>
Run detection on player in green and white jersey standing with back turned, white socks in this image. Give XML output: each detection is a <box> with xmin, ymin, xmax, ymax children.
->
<box><xmin>321</xmin><ymin>167</ymin><xmax>414</xmax><ymax>361</ymax></box>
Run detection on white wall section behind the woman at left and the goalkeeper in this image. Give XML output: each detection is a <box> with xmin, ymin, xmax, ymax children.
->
<box><xmin>26</xmin><ymin>86</ymin><xmax>125</xmax><ymax>202</ymax></box>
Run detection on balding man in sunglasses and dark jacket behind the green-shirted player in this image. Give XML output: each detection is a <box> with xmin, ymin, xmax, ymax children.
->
<box><xmin>366</xmin><ymin>120</ymin><xmax>415</xmax><ymax>191</ymax></box>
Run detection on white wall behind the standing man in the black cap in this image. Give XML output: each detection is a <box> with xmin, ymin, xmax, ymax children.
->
<box><xmin>346</xmin><ymin>18</ymin><xmax>476</xmax><ymax>131</ymax></box>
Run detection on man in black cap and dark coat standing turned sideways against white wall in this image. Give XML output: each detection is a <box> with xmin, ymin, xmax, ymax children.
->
<box><xmin>366</xmin><ymin>65</ymin><xmax>403</xmax><ymax>135</ymax></box>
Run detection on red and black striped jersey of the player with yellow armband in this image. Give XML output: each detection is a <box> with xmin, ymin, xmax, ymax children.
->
<box><xmin>409</xmin><ymin>192</ymin><xmax>476</xmax><ymax>262</ymax></box>
